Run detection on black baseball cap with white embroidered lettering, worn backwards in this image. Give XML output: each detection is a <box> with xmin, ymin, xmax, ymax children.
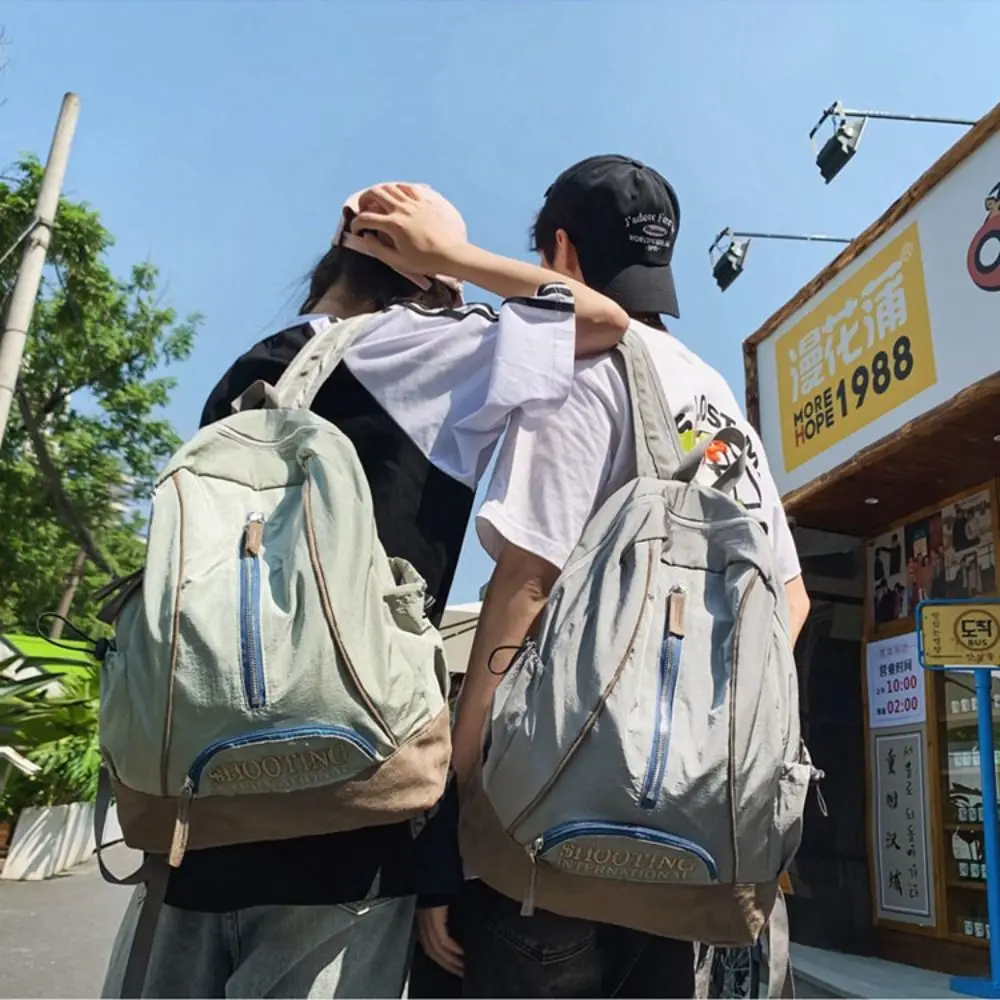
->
<box><xmin>541</xmin><ymin>156</ymin><xmax>681</xmax><ymax>316</ymax></box>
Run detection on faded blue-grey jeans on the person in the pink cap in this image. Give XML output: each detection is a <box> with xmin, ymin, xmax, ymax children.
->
<box><xmin>101</xmin><ymin>886</ymin><xmax>414</xmax><ymax>1000</ymax></box>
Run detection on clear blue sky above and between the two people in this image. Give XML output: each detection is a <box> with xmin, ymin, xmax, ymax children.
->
<box><xmin>0</xmin><ymin>0</ymin><xmax>1000</xmax><ymax>601</ymax></box>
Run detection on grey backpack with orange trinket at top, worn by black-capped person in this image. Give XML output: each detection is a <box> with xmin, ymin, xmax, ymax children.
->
<box><xmin>462</xmin><ymin>332</ymin><xmax>817</xmax><ymax>989</ymax></box>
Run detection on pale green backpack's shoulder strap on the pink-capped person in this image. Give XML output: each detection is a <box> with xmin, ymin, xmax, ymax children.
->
<box><xmin>233</xmin><ymin>313</ymin><xmax>372</xmax><ymax>413</ymax></box>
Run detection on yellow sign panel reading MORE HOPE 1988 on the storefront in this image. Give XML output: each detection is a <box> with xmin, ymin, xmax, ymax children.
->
<box><xmin>775</xmin><ymin>222</ymin><xmax>937</xmax><ymax>472</ymax></box>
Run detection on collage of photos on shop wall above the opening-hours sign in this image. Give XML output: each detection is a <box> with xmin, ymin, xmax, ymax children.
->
<box><xmin>867</xmin><ymin>487</ymin><xmax>997</xmax><ymax>629</ymax></box>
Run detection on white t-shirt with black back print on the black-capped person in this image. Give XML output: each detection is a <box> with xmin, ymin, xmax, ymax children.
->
<box><xmin>476</xmin><ymin>321</ymin><xmax>801</xmax><ymax>583</ymax></box>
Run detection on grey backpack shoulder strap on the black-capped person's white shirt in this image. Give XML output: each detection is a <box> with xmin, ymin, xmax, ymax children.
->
<box><xmin>618</xmin><ymin>329</ymin><xmax>684</xmax><ymax>479</ymax></box>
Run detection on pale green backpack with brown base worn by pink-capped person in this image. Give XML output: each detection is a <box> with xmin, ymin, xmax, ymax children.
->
<box><xmin>98</xmin><ymin>316</ymin><xmax>451</xmax><ymax>991</ymax></box>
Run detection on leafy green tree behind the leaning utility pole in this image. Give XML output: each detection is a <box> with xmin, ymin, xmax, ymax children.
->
<box><xmin>0</xmin><ymin>157</ymin><xmax>199</xmax><ymax>626</ymax></box>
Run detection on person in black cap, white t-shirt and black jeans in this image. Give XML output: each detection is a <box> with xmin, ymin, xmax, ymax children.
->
<box><xmin>418</xmin><ymin>156</ymin><xmax>809</xmax><ymax>997</ymax></box>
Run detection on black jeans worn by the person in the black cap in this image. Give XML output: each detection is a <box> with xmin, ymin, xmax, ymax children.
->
<box><xmin>462</xmin><ymin>881</ymin><xmax>695</xmax><ymax>997</ymax></box>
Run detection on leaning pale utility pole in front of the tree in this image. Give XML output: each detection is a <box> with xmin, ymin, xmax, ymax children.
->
<box><xmin>0</xmin><ymin>93</ymin><xmax>80</xmax><ymax>446</ymax></box>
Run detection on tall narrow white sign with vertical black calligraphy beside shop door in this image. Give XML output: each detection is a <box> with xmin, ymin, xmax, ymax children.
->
<box><xmin>874</xmin><ymin>732</ymin><xmax>933</xmax><ymax>923</ymax></box>
